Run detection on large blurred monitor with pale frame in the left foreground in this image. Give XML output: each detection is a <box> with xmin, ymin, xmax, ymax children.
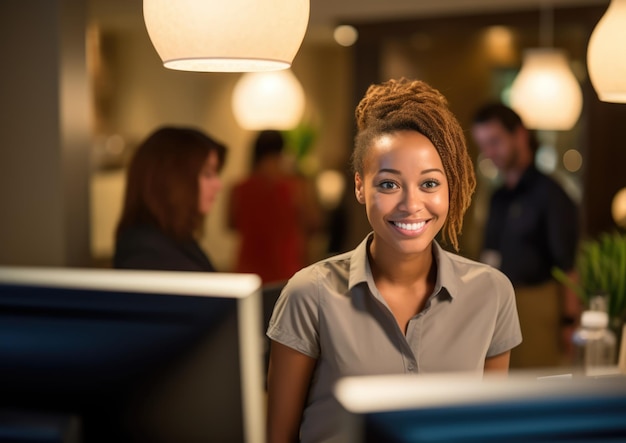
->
<box><xmin>0</xmin><ymin>267</ymin><xmax>265</xmax><ymax>443</ymax></box>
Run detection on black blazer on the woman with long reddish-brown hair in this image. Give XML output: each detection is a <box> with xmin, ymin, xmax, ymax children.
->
<box><xmin>113</xmin><ymin>226</ymin><xmax>215</xmax><ymax>272</ymax></box>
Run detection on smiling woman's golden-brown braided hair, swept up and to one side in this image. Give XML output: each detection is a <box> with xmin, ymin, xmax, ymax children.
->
<box><xmin>352</xmin><ymin>78</ymin><xmax>476</xmax><ymax>251</ymax></box>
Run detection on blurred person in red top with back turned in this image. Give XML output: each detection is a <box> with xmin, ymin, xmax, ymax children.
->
<box><xmin>228</xmin><ymin>130</ymin><xmax>322</xmax><ymax>284</ymax></box>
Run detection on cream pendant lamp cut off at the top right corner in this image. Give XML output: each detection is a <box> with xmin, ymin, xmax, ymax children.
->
<box><xmin>587</xmin><ymin>0</ymin><xmax>626</xmax><ymax>103</ymax></box>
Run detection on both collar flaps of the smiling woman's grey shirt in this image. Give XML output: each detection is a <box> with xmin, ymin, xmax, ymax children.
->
<box><xmin>348</xmin><ymin>233</ymin><xmax>462</xmax><ymax>299</ymax></box>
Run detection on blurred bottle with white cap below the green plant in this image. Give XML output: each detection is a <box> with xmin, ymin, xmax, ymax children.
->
<box><xmin>572</xmin><ymin>311</ymin><xmax>617</xmax><ymax>376</ymax></box>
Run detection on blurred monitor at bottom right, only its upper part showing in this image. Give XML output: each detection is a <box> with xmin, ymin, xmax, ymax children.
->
<box><xmin>335</xmin><ymin>374</ymin><xmax>626</xmax><ymax>443</ymax></box>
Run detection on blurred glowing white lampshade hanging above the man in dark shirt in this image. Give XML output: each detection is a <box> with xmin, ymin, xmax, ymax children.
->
<box><xmin>511</xmin><ymin>48</ymin><xmax>583</xmax><ymax>131</ymax></box>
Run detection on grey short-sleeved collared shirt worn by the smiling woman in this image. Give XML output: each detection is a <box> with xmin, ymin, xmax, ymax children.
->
<box><xmin>267</xmin><ymin>234</ymin><xmax>522</xmax><ymax>442</ymax></box>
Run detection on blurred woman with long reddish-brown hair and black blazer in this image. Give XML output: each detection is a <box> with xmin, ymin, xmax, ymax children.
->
<box><xmin>113</xmin><ymin>127</ymin><xmax>226</xmax><ymax>272</ymax></box>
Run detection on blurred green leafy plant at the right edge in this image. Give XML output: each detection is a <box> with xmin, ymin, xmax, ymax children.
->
<box><xmin>552</xmin><ymin>231</ymin><xmax>626</xmax><ymax>333</ymax></box>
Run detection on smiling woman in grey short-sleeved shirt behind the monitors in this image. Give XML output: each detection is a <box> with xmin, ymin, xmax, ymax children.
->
<box><xmin>267</xmin><ymin>79</ymin><xmax>521</xmax><ymax>442</ymax></box>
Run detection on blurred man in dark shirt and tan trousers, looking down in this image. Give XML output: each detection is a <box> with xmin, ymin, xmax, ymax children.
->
<box><xmin>472</xmin><ymin>103</ymin><xmax>580</xmax><ymax>367</ymax></box>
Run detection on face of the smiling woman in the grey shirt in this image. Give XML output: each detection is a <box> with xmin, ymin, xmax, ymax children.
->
<box><xmin>355</xmin><ymin>131</ymin><xmax>449</xmax><ymax>254</ymax></box>
